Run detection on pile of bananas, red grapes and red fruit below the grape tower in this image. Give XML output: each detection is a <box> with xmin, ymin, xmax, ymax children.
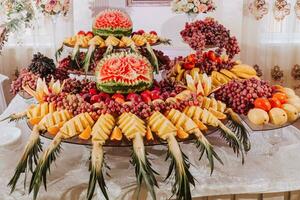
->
<box><xmin>167</xmin><ymin>50</ymin><xmax>259</xmax><ymax>88</ymax></box>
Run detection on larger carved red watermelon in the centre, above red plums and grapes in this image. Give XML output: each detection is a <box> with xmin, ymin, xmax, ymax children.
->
<box><xmin>96</xmin><ymin>52</ymin><xmax>153</xmax><ymax>93</ymax></box>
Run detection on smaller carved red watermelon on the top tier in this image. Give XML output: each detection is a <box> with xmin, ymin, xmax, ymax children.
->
<box><xmin>93</xmin><ymin>9</ymin><xmax>132</xmax><ymax>37</ymax></box>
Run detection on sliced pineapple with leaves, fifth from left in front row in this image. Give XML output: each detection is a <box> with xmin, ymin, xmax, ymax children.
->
<box><xmin>148</xmin><ymin>112</ymin><xmax>195</xmax><ymax>200</ymax></box>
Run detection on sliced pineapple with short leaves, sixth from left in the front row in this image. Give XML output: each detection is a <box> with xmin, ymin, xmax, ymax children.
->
<box><xmin>166</xmin><ymin>107</ymin><xmax>223</xmax><ymax>174</ymax></box>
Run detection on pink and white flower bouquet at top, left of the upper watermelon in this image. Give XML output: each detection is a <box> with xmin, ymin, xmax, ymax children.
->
<box><xmin>36</xmin><ymin>0</ymin><xmax>70</xmax><ymax>16</ymax></box>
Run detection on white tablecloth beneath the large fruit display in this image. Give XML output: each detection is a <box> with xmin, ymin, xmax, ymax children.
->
<box><xmin>0</xmin><ymin>96</ymin><xmax>300</xmax><ymax>200</ymax></box>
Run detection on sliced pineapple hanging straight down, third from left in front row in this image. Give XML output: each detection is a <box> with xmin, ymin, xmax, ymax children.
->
<box><xmin>87</xmin><ymin>114</ymin><xmax>115</xmax><ymax>200</ymax></box>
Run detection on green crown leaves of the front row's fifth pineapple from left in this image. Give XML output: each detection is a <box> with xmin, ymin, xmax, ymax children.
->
<box><xmin>165</xmin><ymin>149</ymin><xmax>195</xmax><ymax>200</ymax></box>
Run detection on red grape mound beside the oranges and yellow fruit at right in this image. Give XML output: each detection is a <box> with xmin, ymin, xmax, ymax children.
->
<box><xmin>214</xmin><ymin>78</ymin><xmax>272</xmax><ymax>115</ymax></box>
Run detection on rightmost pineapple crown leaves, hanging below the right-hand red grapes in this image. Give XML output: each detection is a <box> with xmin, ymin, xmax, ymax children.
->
<box><xmin>227</xmin><ymin>115</ymin><xmax>251</xmax><ymax>152</ymax></box>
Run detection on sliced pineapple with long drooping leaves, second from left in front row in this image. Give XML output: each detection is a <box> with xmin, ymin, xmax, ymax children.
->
<box><xmin>29</xmin><ymin>113</ymin><xmax>94</xmax><ymax>200</ymax></box>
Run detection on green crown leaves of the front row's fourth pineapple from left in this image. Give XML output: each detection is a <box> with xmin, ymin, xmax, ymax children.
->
<box><xmin>130</xmin><ymin>151</ymin><xmax>159</xmax><ymax>200</ymax></box>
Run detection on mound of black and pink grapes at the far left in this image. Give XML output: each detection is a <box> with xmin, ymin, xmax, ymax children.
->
<box><xmin>11</xmin><ymin>53</ymin><xmax>69</xmax><ymax>94</ymax></box>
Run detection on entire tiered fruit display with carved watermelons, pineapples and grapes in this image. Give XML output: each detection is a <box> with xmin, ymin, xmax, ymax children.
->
<box><xmin>5</xmin><ymin>10</ymin><xmax>300</xmax><ymax>200</ymax></box>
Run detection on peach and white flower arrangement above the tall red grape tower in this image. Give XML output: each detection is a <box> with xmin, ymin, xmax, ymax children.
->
<box><xmin>171</xmin><ymin>0</ymin><xmax>216</xmax><ymax>14</ymax></box>
